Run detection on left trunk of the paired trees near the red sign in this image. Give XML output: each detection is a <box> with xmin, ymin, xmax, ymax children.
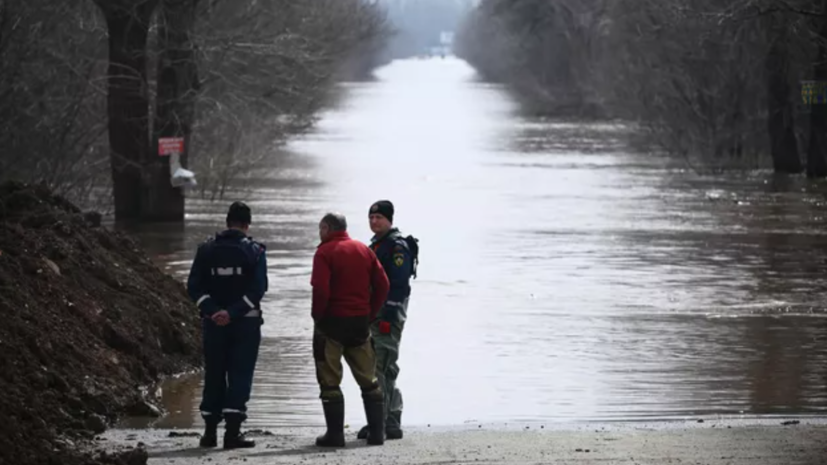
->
<box><xmin>98</xmin><ymin>1</ymin><xmax>155</xmax><ymax>221</ymax></box>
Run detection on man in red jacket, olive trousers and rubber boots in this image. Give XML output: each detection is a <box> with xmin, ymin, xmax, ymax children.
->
<box><xmin>310</xmin><ymin>213</ymin><xmax>390</xmax><ymax>447</ymax></box>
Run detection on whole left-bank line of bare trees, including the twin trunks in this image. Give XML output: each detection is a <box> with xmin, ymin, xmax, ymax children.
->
<box><xmin>0</xmin><ymin>0</ymin><xmax>390</xmax><ymax>219</ymax></box>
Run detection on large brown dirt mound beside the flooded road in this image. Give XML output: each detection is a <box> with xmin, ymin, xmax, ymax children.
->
<box><xmin>0</xmin><ymin>183</ymin><xmax>201</xmax><ymax>465</ymax></box>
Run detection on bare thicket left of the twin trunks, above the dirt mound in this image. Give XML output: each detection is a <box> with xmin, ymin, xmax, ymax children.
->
<box><xmin>0</xmin><ymin>0</ymin><xmax>108</xmax><ymax>205</ymax></box>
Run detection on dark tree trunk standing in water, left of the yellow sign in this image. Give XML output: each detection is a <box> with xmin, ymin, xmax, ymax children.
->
<box><xmin>765</xmin><ymin>15</ymin><xmax>802</xmax><ymax>174</ymax></box>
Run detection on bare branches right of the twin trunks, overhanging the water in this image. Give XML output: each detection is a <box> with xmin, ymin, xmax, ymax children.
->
<box><xmin>192</xmin><ymin>0</ymin><xmax>388</xmax><ymax>198</ymax></box>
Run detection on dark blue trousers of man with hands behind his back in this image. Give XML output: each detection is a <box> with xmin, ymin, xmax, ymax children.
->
<box><xmin>201</xmin><ymin>317</ymin><xmax>263</xmax><ymax>423</ymax></box>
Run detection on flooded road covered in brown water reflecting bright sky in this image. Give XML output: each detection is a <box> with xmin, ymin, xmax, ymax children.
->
<box><xmin>129</xmin><ymin>59</ymin><xmax>827</xmax><ymax>428</ymax></box>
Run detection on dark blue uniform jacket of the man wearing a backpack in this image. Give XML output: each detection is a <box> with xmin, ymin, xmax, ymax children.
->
<box><xmin>370</xmin><ymin>228</ymin><xmax>413</xmax><ymax>323</ymax></box>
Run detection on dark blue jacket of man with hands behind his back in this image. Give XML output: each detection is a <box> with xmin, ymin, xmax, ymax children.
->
<box><xmin>187</xmin><ymin>229</ymin><xmax>268</xmax><ymax>320</ymax></box>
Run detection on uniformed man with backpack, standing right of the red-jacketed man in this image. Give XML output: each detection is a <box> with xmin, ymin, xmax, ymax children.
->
<box><xmin>357</xmin><ymin>200</ymin><xmax>416</xmax><ymax>439</ymax></box>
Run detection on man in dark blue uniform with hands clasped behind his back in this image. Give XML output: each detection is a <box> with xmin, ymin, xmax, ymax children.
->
<box><xmin>187</xmin><ymin>202</ymin><xmax>268</xmax><ymax>449</ymax></box>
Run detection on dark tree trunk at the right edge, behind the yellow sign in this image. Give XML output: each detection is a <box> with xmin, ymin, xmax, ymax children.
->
<box><xmin>807</xmin><ymin>0</ymin><xmax>827</xmax><ymax>178</ymax></box>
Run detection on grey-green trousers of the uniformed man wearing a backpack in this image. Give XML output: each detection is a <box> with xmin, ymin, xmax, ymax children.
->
<box><xmin>370</xmin><ymin>300</ymin><xmax>408</xmax><ymax>428</ymax></box>
